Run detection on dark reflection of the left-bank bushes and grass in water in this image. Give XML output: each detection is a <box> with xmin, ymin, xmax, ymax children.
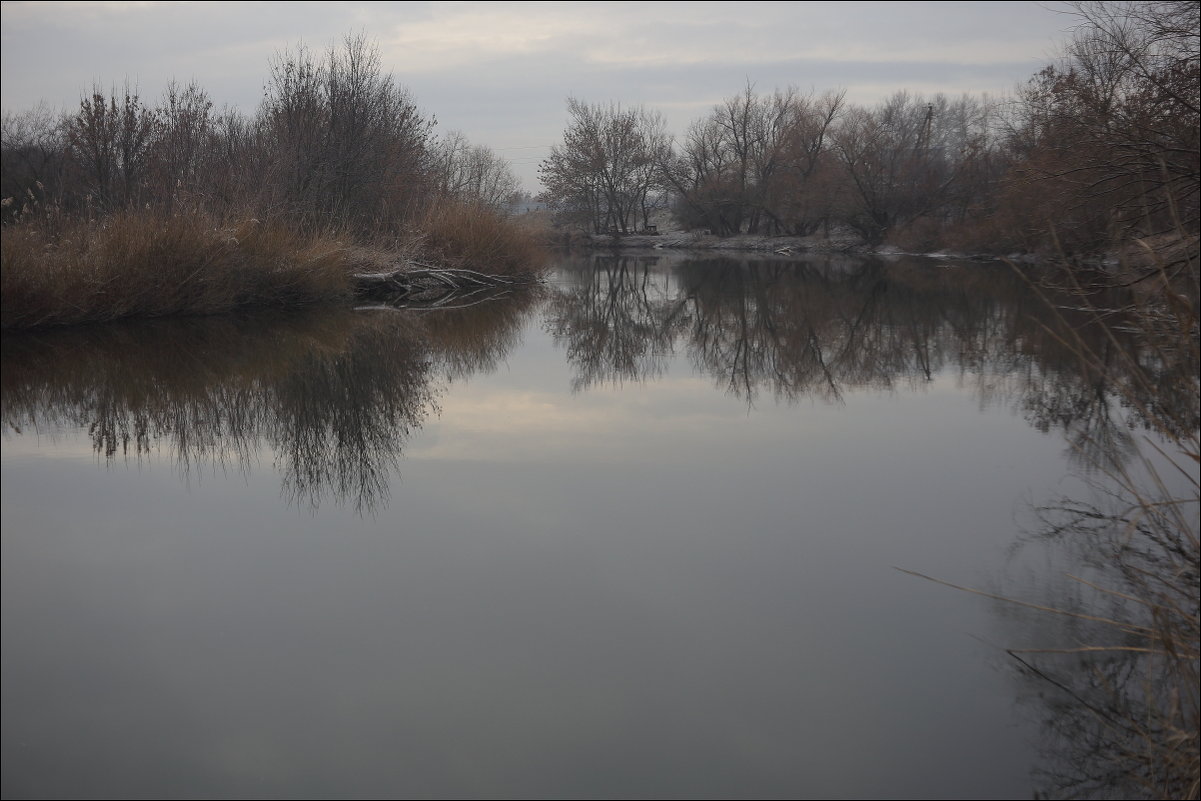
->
<box><xmin>0</xmin><ymin>300</ymin><xmax>530</xmax><ymax>513</ymax></box>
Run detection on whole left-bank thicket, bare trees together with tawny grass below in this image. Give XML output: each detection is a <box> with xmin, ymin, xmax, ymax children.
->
<box><xmin>0</xmin><ymin>36</ymin><xmax>540</xmax><ymax>328</ymax></box>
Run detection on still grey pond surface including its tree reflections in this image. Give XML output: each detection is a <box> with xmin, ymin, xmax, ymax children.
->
<box><xmin>2</xmin><ymin>258</ymin><xmax>1162</xmax><ymax>797</ymax></box>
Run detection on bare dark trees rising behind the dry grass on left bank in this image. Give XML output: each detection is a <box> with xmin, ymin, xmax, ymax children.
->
<box><xmin>0</xmin><ymin>35</ymin><xmax>519</xmax><ymax>235</ymax></box>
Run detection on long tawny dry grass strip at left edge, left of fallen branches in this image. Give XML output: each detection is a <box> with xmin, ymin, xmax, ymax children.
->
<box><xmin>0</xmin><ymin>211</ymin><xmax>371</xmax><ymax>328</ymax></box>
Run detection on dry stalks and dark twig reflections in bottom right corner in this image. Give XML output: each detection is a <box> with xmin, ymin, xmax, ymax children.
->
<box><xmin>914</xmin><ymin>443</ymin><xmax>1199</xmax><ymax>799</ymax></box>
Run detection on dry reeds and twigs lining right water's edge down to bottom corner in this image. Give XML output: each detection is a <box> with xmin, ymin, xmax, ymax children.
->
<box><xmin>898</xmin><ymin>206</ymin><xmax>1201</xmax><ymax>799</ymax></box>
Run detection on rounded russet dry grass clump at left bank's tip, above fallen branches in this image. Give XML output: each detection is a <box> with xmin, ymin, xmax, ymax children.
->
<box><xmin>419</xmin><ymin>199</ymin><xmax>546</xmax><ymax>275</ymax></box>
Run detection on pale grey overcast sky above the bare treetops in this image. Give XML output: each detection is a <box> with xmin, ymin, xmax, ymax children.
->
<box><xmin>0</xmin><ymin>1</ymin><xmax>1075</xmax><ymax>191</ymax></box>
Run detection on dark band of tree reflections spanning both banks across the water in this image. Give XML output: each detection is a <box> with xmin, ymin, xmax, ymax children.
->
<box><xmin>0</xmin><ymin>256</ymin><xmax>1181</xmax><ymax>510</ymax></box>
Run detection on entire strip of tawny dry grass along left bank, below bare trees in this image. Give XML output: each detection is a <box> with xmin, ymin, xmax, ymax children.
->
<box><xmin>0</xmin><ymin>201</ymin><xmax>543</xmax><ymax>329</ymax></box>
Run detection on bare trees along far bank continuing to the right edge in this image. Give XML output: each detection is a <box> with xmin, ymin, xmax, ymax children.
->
<box><xmin>540</xmin><ymin>2</ymin><xmax>1201</xmax><ymax>252</ymax></box>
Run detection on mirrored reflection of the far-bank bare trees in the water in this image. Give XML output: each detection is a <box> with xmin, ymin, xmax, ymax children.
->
<box><xmin>548</xmin><ymin>257</ymin><xmax>1196</xmax><ymax>459</ymax></box>
